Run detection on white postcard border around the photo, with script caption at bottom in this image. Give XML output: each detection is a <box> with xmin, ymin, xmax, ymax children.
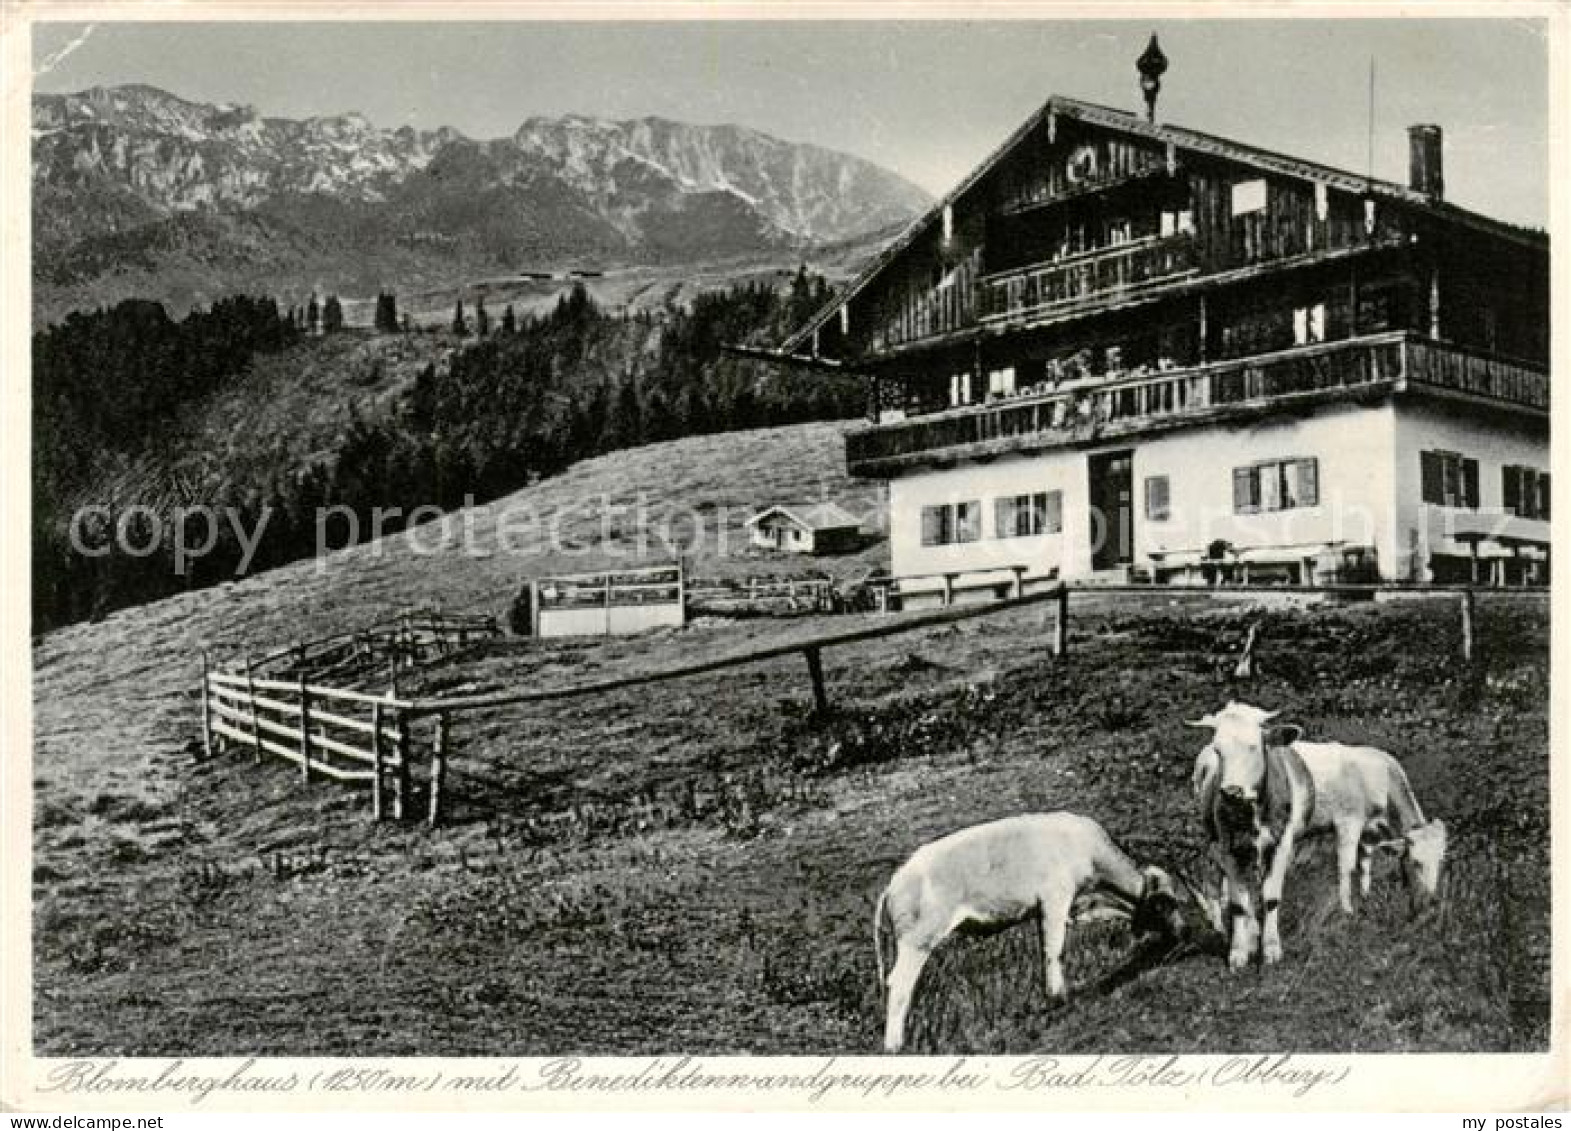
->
<box><xmin>0</xmin><ymin>0</ymin><xmax>1571</xmax><ymax>1112</ymax></box>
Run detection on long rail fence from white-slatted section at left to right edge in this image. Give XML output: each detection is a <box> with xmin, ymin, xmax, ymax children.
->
<box><xmin>203</xmin><ymin>583</ymin><xmax>1549</xmax><ymax>826</ymax></box>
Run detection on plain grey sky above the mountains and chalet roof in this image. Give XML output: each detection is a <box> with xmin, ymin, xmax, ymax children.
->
<box><xmin>33</xmin><ymin>19</ymin><xmax>1549</xmax><ymax>228</ymax></box>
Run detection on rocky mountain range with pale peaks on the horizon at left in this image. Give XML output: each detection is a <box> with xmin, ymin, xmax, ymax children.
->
<box><xmin>33</xmin><ymin>85</ymin><xmax>928</xmax><ymax>317</ymax></box>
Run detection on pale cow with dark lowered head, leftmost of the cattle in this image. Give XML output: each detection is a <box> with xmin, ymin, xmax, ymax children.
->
<box><xmin>873</xmin><ymin>812</ymin><xmax>1185</xmax><ymax>1052</ymax></box>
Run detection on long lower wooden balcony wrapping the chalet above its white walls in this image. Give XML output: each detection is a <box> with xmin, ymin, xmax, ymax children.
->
<box><xmin>845</xmin><ymin>333</ymin><xmax>1549</xmax><ymax>476</ymax></box>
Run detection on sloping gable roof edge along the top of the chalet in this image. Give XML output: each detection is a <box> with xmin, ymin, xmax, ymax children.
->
<box><xmin>781</xmin><ymin>94</ymin><xmax>1549</xmax><ymax>353</ymax></box>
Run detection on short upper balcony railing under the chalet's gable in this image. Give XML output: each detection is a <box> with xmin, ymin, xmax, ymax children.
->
<box><xmin>977</xmin><ymin>232</ymin><xmax>1197</xmax><ymax>322</ymax></box>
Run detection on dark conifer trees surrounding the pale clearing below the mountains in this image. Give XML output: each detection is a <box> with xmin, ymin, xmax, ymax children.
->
<box><xmin>33</xmin><ymin>272</ymin><xmax>864</xmax><ymax>631</ymax></box>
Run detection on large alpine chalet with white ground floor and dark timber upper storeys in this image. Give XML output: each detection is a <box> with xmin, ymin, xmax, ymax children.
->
<box><xmin>784</xmin><ymin>76</ymin><xmax>1549</xmax><ymax>605</ymax></box>
